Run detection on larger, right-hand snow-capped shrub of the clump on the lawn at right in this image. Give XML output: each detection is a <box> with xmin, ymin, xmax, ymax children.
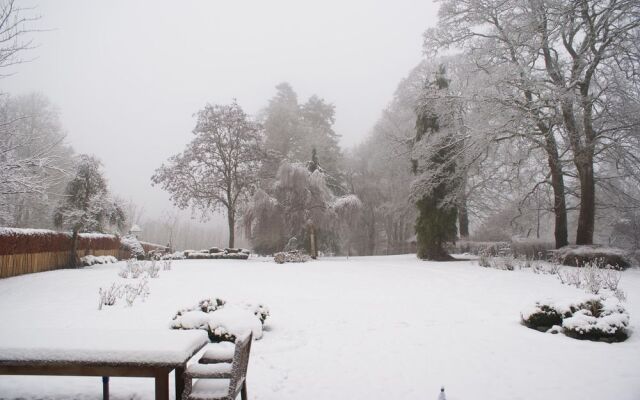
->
<box><xmin>562</xmin><ymin>297</ymin><xmax>629</xmax><ymax>343</ymax></box>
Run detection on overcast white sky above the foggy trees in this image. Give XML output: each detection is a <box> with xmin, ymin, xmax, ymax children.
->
<box><xmin>2</xmin><ymin>0</ymin><xmax>438</xmax><ymax>216</ymax></box>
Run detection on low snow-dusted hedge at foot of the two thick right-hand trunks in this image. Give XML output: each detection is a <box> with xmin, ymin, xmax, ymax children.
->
<box><xmin>554</xmin><ymin>245</ymin><xmax>631</xmax><ymax>269</ymax></box>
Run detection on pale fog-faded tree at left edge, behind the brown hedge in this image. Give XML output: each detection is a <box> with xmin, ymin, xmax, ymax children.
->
<box><xmin>0</xmin><ymin>94</ymin><xmax>73</xmax><ymax>228</ymax></box>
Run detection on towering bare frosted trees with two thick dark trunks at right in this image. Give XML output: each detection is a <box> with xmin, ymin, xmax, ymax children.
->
<box><xmin>425</xmin><ymin>0</ymin><xmax>640</xmax><ymax>244</ymax></box>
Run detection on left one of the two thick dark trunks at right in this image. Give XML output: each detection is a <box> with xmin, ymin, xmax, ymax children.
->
<box><xmin>545</xmin><ymin>130</ymin><xmax>569</xmax><ymax>249</ymax></box>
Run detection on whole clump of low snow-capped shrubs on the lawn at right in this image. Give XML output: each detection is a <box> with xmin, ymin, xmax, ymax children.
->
<box><xmin>520</xmin><ymin>296</ymin><xmax>629</xmax><ymax>343</ymax></box>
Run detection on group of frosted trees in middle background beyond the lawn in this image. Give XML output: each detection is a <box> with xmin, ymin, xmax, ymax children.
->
<box><xmin>151</xmin><ymin>83</ymin><xmax>360</xmax><ymax>256</ymax></box>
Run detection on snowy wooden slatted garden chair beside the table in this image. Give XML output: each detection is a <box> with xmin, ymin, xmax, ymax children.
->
<box><xmin>182</xmin><ymin>332</ymin><xmax>253</xmax><ymax>400</ymax></box>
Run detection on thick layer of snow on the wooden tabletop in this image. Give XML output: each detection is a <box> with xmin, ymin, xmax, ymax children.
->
<box><xmin>0</xmin><ymin>327</ymin><xmax>208</xmax><ymax>364</ymax></box>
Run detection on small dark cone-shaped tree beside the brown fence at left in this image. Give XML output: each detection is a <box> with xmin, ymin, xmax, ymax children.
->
<box><xmin>54</xmin><ymin>155</ymin><xmax>126</xmax><ymax>267</ymax></box>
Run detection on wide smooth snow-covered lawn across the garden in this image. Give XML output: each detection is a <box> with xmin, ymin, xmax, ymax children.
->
<box><xmin>0</xmin><ymin>255</ymin><xmax>640</xmax><ymax>400</ymax></box>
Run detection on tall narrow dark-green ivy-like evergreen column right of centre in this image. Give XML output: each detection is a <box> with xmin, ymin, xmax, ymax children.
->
<box><xmin>411</xmin><ymin>66</ymin><xmax>461</xmax><ymax>261</ymax></box>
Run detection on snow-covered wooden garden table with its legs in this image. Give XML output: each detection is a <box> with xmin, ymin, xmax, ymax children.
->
<box><xmin>0</xmin><ymin>328</ymin><xmax>209</xmax><ymax>400</ymax></box>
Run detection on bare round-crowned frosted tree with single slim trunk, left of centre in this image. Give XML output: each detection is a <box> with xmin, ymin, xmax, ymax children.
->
<box><xmin>151</xmin><ymin>101</ymin><xmax>262</xmax><ymax>247</ymax></box>
